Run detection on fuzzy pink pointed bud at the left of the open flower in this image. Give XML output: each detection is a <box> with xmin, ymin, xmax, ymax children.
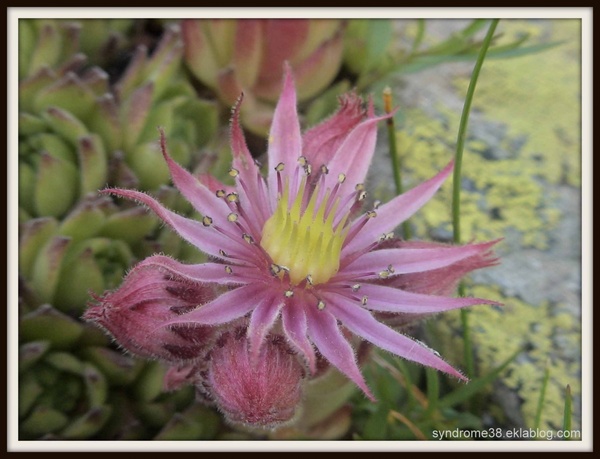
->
<box><xmin>84</xmin><ymin>256</ymin><xmax>214</xmax><ymax>363</ymax></box>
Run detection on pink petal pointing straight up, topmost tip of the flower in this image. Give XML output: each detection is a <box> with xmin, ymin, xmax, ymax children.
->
<box><xmin>268</xmin><ymin>65</ymin><xmax>302</xmax><ymax>198</ymax></box>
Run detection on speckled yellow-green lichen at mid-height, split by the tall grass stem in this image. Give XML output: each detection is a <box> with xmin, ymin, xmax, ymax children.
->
<box><xmin>398</xmin><ymin>107</ymin><xmax>560</xmax><ymax>249</ymax></box>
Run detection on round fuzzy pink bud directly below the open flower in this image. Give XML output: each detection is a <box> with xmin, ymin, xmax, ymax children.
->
<box><xmin>208</xmin><ymin>332</ymin><xmax>303</xmax><ymax>428</ymax></box>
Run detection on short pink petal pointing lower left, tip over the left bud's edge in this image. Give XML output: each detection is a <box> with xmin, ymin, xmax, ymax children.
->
<box><xmin>165</xmin><ymin>283</ymin><xmax>265</xmax><ymax>325</ymax></box>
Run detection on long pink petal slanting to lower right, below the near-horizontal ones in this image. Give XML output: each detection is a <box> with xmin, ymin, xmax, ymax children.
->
<box><xmin>328</xmin><ymin>296</ymin><xmax>466</xmax><ymax>380</ymax></box>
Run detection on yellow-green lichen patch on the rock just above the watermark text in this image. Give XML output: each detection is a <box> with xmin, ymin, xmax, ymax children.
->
<box><xmin>435</xmin><ymin>286</ymin><xmax>581</xmax><ymax>429</ymax></box>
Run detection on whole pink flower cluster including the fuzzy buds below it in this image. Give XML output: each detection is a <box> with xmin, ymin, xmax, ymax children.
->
<box><xmin>86</xmin><ymin>66</ymin><xmax>496</xmax><ymax>427</ymax></box>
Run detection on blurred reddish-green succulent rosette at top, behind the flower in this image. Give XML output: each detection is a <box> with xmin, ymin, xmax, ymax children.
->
<box><xmin>181</xmin><ymin>19</ymin><xmax>345</xmax><ymax>135</ymax></box>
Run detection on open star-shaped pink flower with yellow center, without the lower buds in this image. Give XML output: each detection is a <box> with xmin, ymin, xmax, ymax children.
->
<box><xmin>96</xmin><ymin>68</ymin><xmax>496</xmax><ymax>403</ymax></box>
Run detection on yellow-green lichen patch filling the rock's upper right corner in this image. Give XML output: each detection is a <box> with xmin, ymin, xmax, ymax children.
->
<box><xmin>456</xmin><ymin>19</ymin><xmax>581</xmax><ymax>186</ymax></box>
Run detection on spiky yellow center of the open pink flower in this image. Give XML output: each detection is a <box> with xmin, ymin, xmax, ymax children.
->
<box><xmin>260</xmin><ymin>178</ymin><xmax>348</xmax><ymax>285</ymax></box>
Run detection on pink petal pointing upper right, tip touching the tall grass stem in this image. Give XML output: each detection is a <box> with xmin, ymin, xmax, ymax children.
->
<box><xmin>342</xmin><ymin>161</ymin><xmax>454</xmax><ymax>257</ymax></box>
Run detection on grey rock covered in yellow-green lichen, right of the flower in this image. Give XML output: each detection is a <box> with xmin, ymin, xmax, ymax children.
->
<box><xmin>371</xmin><ymin>20</ymin><xmax>582</xmax><ymax>429</ymax></box>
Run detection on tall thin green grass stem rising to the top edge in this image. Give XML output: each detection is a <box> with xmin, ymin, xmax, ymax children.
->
<box><xmin>452</xmin><ymin>19</ymin><xmax>500</xmax><ymax>376</ymax></box>
